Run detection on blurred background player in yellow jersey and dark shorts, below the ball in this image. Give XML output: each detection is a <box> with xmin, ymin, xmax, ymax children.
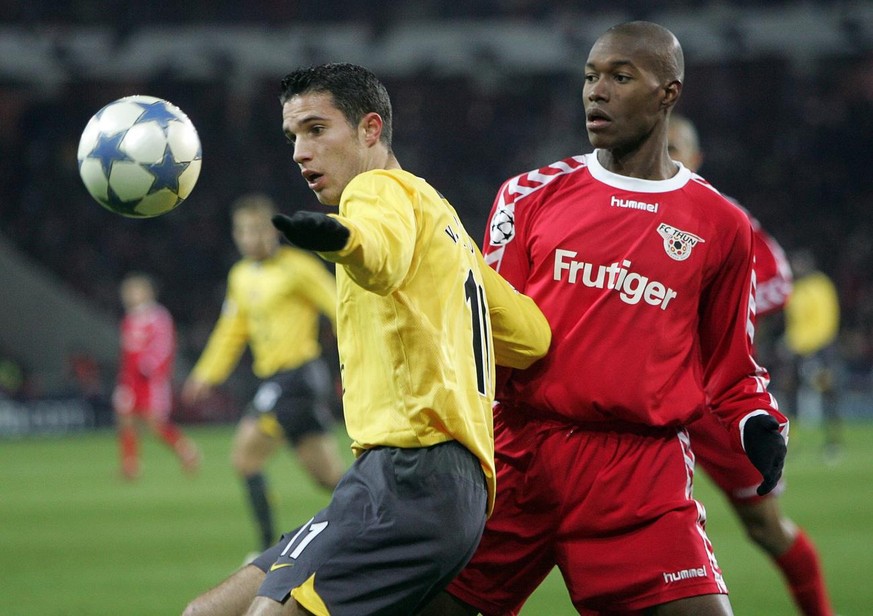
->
<box><xmin>182</xmin><ymin>194</ymin><xmax>346</xmax><ymax>550</ymax></box>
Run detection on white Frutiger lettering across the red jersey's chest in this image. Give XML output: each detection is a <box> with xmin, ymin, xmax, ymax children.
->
<box><xmin>553</xmin><ymin>248</ymin><xmax>677</xmax><ymax>310</ymax></box>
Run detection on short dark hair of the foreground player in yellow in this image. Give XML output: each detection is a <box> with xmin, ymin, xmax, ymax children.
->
<box><xmin>279</xmin><ymin>63</ymin><xmax>393</xmax><ymax>149</ymax></box>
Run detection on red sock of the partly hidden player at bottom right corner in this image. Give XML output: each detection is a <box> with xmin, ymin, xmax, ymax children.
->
<box><xmin>774</xmin><ymin>530</ymin><xmax>834</xmax><ymax>616</ymax></box>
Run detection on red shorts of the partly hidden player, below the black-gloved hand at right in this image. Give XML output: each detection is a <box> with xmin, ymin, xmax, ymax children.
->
<box><xmin>688</xmin><ymin>413</ymin><xmax>785</xmax><ymax>503</ymax></box>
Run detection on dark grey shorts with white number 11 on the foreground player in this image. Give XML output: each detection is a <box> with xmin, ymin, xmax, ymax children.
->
<box><xmin>253</xmin><ymin>441</ymin><xmax>488</xmax><ymax>616</ymax></box>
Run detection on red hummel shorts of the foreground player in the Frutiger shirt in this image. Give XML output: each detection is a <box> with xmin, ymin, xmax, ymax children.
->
<box><xmin>448</xmin><ymin>409</ymin><xmax>727</xmax><ymax>616</ymax></box>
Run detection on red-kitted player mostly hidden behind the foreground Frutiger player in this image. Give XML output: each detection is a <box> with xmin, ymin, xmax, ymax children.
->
<box><xmin>667</xmin><ymin>113</ymin><xmax>833</xmax><ymax>616</ymax></box>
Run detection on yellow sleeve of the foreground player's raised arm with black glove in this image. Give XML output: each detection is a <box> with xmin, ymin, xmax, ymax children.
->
<box><xmin>319</xmin><ymin>171</ymin><xmax>415</xmax><ymax>295</ymax></box>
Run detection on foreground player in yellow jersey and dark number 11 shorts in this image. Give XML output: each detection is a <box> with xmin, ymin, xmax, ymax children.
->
<box><xmin>185</xmin><ymin>64</ymin><xmax>550</xmax><ymax>616</ymax></box>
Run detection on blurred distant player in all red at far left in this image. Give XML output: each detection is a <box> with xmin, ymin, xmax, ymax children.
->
<box><xmin>112</xmin><ymin>272</ymin><xmax>200</xmax><ymax>480</ymax></box>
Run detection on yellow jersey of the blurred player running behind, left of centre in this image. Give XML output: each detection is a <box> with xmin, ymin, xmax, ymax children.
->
<box><xmin>193</xmin><ymin>246</ymin><xmax>336</xmax><ymax>384</ymax></box>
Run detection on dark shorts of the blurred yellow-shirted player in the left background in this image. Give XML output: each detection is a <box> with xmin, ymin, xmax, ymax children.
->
<box><xmin>247</xmin><ymin>359</ymin><xmax>334</xmax><ymax>445</ymax></box>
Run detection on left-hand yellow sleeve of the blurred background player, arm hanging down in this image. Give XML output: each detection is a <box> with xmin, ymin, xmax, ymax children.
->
<box><xmin>191</xmin><ymin>278</ymin><xmax>248</xmax><ymax>385</ymax></box>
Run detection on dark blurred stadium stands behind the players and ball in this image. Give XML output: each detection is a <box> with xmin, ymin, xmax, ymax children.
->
<box><xmin>0</xmin><ymin>0</ymin><xmax>873</xmax><ymax>613</ymax></box>
